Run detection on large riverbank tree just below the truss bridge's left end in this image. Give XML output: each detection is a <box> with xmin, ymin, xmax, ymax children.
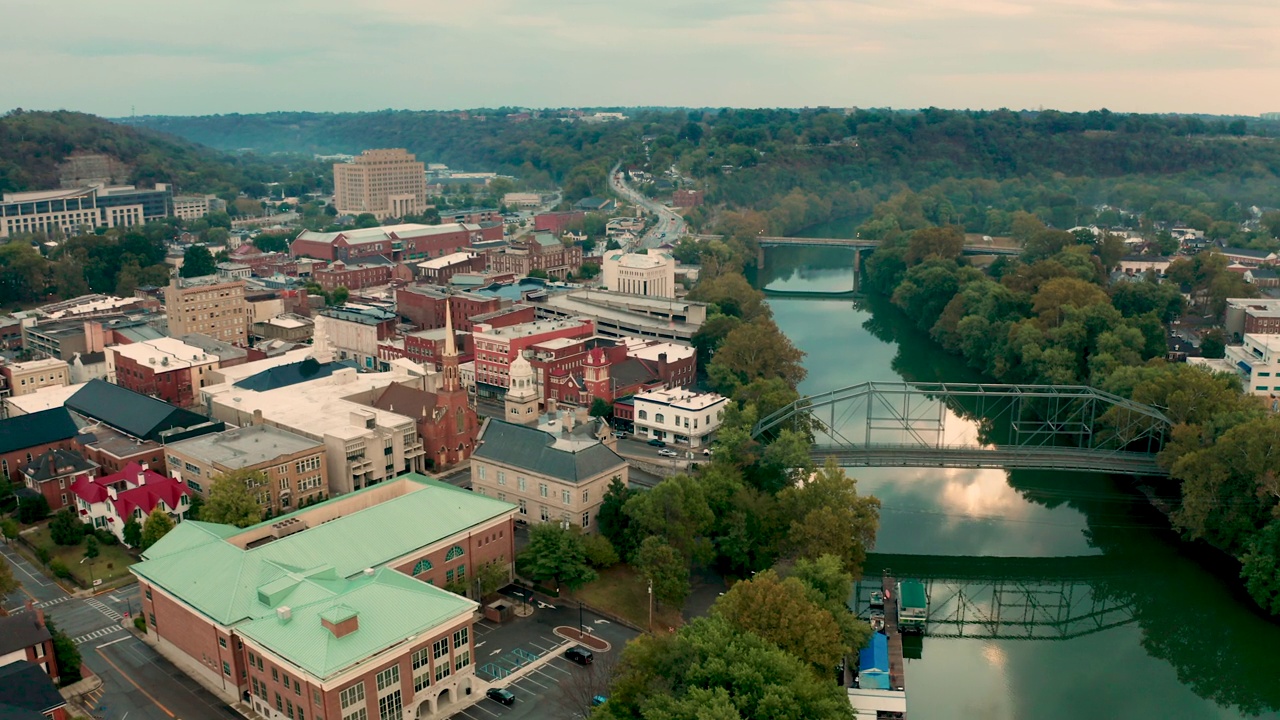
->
<box><xmin>778</xmin><ymin>459</ymin><xmax>879</xmax><ymax>577</ymax></box>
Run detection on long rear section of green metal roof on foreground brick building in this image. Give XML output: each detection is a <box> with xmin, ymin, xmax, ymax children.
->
<box><xmin>132</xmin><ymin>473</ymin><xmax>515</xmax><ymax>625</ymax></box>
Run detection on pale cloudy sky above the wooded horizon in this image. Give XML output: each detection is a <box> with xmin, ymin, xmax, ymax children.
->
<box><xmin>0</xmin><ymin>0</ymin><xmax>1280</xmax><ymax>117</ymax></box>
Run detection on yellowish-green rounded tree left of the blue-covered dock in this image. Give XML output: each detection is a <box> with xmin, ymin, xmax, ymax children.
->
<box><xmin>712</xmin><ymin>570</ymin><xmax>847</xmax><ymax>671</ymax></box>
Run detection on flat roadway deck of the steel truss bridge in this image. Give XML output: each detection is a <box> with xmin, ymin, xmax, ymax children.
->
<box><xmin>812</xmin><ymin>445</ymin><xmax>1169</xmax><ymax>477</ymax></box>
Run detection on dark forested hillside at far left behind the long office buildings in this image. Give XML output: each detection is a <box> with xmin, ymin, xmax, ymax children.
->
<box><xmin>0</xmin><ymin>110</ymin><xmax>324</xmax><ymax>197</ymax></box>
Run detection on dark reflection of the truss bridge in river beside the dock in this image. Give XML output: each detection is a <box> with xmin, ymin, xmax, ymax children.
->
<box><xmin>855</xmin><ymin>553</ymin><xmax>1135</xmax><ymax>641</ymax></box>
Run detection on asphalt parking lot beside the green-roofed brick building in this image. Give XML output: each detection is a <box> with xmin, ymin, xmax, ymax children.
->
<box><xmin>452</xmin><ymin>593</ymin><xmax>637</xmax><ymax>720</ymax></box>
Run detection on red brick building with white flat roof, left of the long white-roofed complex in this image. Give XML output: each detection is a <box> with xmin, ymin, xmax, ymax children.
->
<box><xmin>106</xmin><ymin>337</ymin><xmax>219</xmax><ymax>407</ymax></box>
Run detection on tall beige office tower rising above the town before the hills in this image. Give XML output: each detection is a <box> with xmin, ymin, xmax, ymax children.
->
<box><xmin>333</xmin><ymin>147</ymin><xmax>426</xmax><ymax>219</ymax></box>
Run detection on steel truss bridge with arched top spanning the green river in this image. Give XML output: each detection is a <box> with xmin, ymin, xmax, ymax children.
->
<box><xmin>751</xmin><ymin>382</ymin><xmax>1171</xmax><ymax>475</ymax></box>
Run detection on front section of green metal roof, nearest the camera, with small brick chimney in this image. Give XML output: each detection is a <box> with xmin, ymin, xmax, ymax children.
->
<box><xmin>236</xmin><ymin>568</ymin><xmax>476</xmax><ymax>679</ymax></box>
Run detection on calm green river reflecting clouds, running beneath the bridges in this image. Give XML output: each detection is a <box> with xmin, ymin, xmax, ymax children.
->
<box><xmin>760</xmin><ymin>244</ymin><xmax>1280</xmax><ymax>720</ymax></box>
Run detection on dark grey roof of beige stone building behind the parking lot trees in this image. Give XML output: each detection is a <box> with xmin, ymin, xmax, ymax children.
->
<box><xmin>474</xmin><ymin>419</ymin><xmax>626</xmax><ymax>483</ymax></box>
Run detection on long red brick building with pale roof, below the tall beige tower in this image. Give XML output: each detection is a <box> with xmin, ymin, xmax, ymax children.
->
<box><xmin>289</xmin><ymin>223</ymin><xmax>481</xmax><ymax>263</ymax></box>
